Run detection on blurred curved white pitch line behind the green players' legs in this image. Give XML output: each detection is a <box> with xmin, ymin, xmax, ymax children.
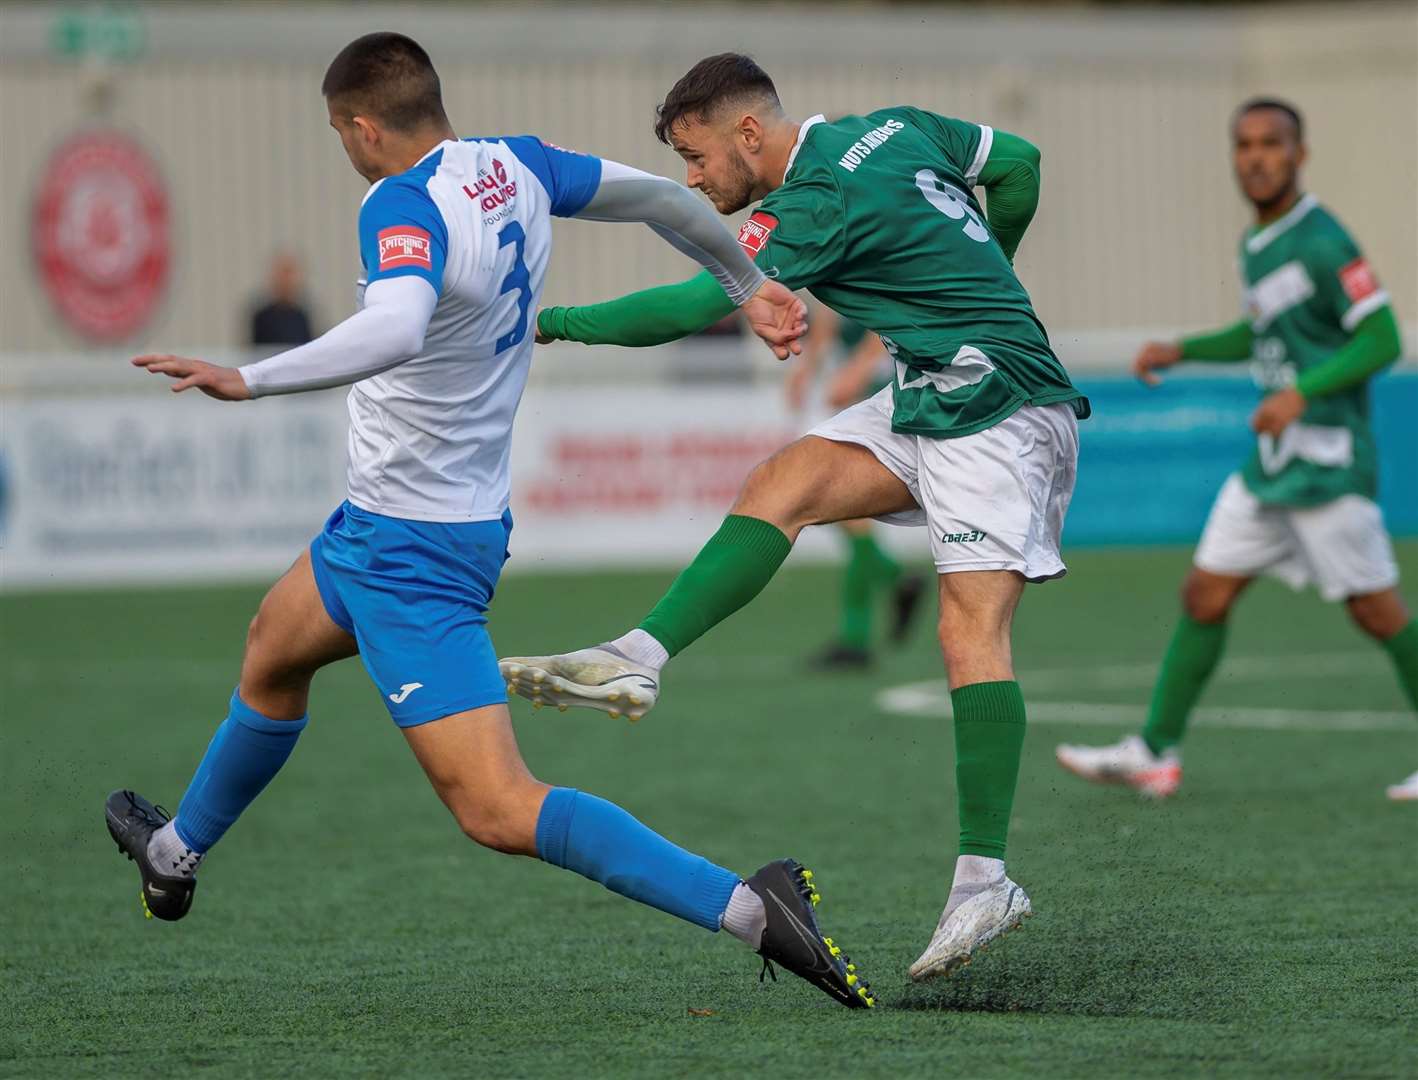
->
<box><xmin>876</xmin><ymin>679</ymin><xmax>1418</xmax><ymax>734</ymax></box>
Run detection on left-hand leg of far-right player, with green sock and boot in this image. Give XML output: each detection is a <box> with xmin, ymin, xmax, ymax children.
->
<box><xmin>1054</xmin><ymin>567</ymin><xmax>1255</xmax><ymax>798</ymax></box>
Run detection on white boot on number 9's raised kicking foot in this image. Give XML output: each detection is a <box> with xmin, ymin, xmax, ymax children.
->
<box><xmin>498</xmin><ymin>645</ymin><xmax>659</xmax><ymax>720</ymax></box>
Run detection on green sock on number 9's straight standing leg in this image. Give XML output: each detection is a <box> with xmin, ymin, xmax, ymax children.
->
<box><xmin>950</xmin><ymin>682</ymin><xmax>1024</xmax><ymax>859</ymax></box>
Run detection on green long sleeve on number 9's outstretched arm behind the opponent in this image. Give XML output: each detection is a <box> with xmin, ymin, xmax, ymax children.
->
<box><xmin>536</xmin><ymin>271</ymin><xmax>735</xmax><ymax>347</ymax></box>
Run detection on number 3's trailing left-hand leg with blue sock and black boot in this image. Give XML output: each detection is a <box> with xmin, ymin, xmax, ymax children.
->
<box><xmin>105</xmin><ymin>551</ymin><xmax>357</xmax><ymax>920</ymax></box>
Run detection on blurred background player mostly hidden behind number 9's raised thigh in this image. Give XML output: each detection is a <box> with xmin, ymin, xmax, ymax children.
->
<box><xmin>783</xmin><ymin>305</ymin><xmax>926</xmax><ymax>672</ymax></box>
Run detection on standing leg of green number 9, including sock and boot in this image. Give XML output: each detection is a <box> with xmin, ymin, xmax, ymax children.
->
<box><xmin>910</xmin><ymin>570</ymin><xmax>1032</xmax><ymax>979</ymax></box>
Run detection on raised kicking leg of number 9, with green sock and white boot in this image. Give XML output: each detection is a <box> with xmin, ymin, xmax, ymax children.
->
<box><xmin>501</xmin><ymin>435</ymin><xmax>916</xmax><ymax>720</ymax></box>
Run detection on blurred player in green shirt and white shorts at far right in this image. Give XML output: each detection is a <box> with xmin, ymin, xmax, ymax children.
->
<box><xmin>1058</xmin><ymin>99</ymin><xmax>1418</xmax><ymax>799</ymax></box>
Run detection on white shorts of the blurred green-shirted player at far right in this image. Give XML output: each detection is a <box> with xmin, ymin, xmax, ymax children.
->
<box><xmin>1193</xmin><ymin>473</ymin><xmax>1398</xmax><ymax>601</ymax></box>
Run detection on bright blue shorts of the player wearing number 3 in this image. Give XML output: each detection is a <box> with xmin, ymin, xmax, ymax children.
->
<box><xmin>311</xmin><ymin>502</ymin><xmax>512</xmax><ymax>727</ymax></box>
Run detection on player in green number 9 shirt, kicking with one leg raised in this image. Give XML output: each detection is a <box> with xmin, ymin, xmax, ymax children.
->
<box><xmin>502</xmin><ymin>54</ymin><xmax>1088</xmax><ymax>979</ymax></box>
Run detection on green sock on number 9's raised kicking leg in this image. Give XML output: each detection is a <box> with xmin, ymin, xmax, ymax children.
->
<box><xmin>640</xmin><ymin>514</ymin><xmax>793</xmax><ymax>656</ymax></box>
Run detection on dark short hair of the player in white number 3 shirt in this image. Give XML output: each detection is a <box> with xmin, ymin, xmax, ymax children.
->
<box><xmin>320</xmin><ymin>33</ymin><xmax>448</xmax><ymax>132</ymax></box>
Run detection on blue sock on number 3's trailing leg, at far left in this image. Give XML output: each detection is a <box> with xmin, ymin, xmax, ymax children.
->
<box><xmin>176</xmin><ymin>693</ymin><xmax>309</xmax><ymax>852</ymax></box>
